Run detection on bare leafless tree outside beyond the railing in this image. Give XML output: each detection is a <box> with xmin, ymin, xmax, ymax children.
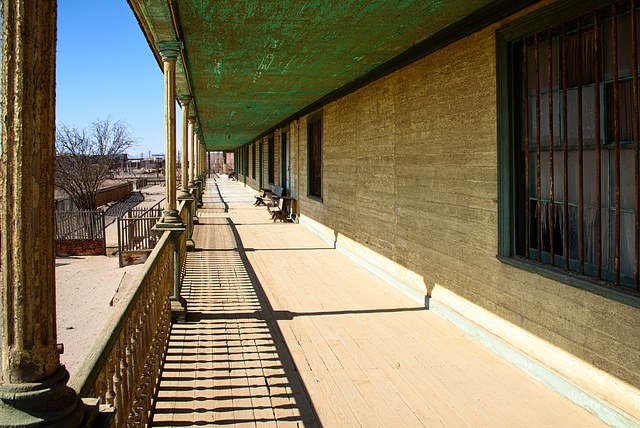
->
<box><xmin>56</xmin><ymin>118</ymin><xmax>137</xmax><ymax>209</ymax></box>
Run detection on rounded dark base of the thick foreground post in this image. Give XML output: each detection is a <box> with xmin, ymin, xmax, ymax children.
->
<box><xmin>0</xmin><ymin>365</ymin><xmax>85</xmax><ymax>428</ymax></box>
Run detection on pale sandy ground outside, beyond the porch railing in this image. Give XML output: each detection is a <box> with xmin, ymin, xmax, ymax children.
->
<box><xmin>56</xmin><ymin>186</ymin><xmax>165</xmax><ymax>375</ymax></box>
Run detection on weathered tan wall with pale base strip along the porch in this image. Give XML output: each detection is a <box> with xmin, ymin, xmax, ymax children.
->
<box><xmin>235</xmin><ymin>2</ymin><xmax>640</xmax><ymax>416</ymax></box>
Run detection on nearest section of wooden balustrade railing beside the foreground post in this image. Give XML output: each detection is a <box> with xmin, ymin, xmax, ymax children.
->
<box><xmin>69</xmin><ymin>232</ymin><xmax>174</xmax><ymax>427</ymax></box>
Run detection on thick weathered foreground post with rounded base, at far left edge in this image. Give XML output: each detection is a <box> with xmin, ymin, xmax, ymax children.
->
<box><xmin>0</xmin><ymin>0</ymin><xmax>84</xmax><ymax>427</ymax></box>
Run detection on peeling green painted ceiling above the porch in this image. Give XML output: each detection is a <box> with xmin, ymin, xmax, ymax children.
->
<box><xmin>128</xmin><ymin>0</ymin><xmax>500</xmax><ymax>150</ymax></box>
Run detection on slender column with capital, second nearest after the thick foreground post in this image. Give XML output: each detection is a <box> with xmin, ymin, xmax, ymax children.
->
<box><xmin>157</xmin><ymin>42</ymin><xmax>182</xmax><ymax>223</ymax></box>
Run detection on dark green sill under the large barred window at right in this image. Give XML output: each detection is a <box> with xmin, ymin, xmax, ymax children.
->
<box><xmin>496</xmin><ymin>255</ymin><xmax>640</xmax><ymax>309</ymax></box>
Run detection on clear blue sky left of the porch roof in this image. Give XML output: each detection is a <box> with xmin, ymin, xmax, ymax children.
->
<box><xmin>56</xmin><ymin>0</ymin><xmax>175</xmax><ymax>156</ymax></box>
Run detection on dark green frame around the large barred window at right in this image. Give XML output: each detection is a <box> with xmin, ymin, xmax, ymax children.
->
<box><xmin>496</xmin><ymin>0</ymin><xmax>640</xmax><ymax>308</ymax></box>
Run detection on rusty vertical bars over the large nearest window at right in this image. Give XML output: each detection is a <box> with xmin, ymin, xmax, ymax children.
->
<box><xmin>514</xmin><ymin>1</ymin><xmax>640</xmax><ymax>293</ymax></box>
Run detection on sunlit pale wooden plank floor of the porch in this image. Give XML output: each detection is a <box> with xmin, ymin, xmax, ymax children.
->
<box><xmin>153</xmin><ymin>179</ymin><xmax>604</xmax><ymax>427</ymax></box>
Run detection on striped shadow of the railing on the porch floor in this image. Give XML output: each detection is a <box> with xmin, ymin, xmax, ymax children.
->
<box><xmin>153</xmin><ymin>219</ymin><xmax>321</xmax><ymax>427</ymax></box>
